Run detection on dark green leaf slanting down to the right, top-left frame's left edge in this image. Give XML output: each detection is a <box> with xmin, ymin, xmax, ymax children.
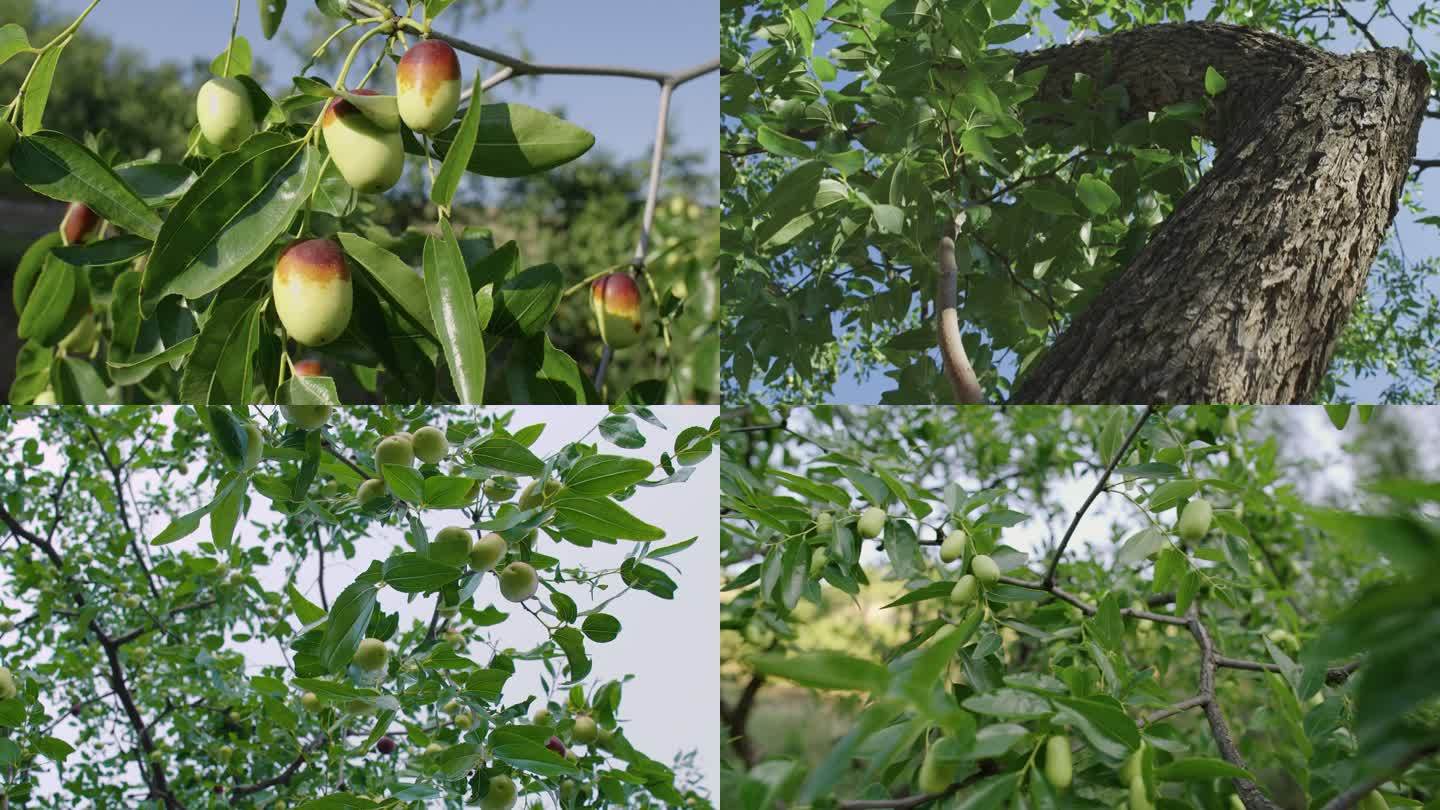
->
<box><xmin>10</xmin><ymin>130</ymin><xmax>161</xmax><ymax>239</ymax></box>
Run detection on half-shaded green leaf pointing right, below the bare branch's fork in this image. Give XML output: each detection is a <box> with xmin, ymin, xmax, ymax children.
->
<box><xmin>416</xmin><ymin>104</ymin><xmax>595</xmax><ymax>177</ymax></box>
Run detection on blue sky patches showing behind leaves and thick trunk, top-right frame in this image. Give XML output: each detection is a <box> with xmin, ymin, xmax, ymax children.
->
<box><xmin>756</xmin><ymin>0</ymin><xmax>1440</xmax><ymax>404</ymax></box>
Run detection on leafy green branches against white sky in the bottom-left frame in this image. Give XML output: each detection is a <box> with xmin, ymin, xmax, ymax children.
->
<box><xmin>0</xmin><ymin>408</ymin><xmax>713</xmax><ymax>810</ymax></box>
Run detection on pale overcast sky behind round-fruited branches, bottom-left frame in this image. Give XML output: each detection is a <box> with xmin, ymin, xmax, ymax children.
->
<box><xmin>0</xmin><ymin>406</ymin><xmax>720</xmax><ymax>800</ymax></box>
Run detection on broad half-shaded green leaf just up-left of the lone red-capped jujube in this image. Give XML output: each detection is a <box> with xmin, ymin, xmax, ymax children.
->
<box><xmin>141</xmin><ymin>133</ymin><xmax>321</xmax><ymax>305</ymax></box>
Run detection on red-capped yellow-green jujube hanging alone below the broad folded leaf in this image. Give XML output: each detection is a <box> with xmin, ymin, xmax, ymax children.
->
<box><xmin>272</xmin><ymin>239</ymin><xmax>354</xmax><ymax>346</ymax></box>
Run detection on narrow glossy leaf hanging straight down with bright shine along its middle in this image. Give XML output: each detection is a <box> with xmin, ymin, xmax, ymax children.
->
<box><xmin>425</xmin><ymin>218</ymin><xmax>485</xmax><ymax>405</ymax></box>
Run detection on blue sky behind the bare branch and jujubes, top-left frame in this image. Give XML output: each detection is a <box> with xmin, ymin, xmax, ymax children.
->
<box><xmin>46</xmin><ymin>0</ymin><xmax>720</xmax><ymax>172</ymax></box>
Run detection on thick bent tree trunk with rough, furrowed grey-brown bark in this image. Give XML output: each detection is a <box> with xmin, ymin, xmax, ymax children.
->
<box><xmin>1011</xmin><ymin>23</ymin><xmax>1428</xmax><ymax>404</ymax></box>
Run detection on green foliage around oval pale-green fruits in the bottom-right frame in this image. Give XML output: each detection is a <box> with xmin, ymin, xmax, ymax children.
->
<box><xmin>721</xmin><ymin>406</ymin><xmax>1440</xmax><ymax>810</ymax></box>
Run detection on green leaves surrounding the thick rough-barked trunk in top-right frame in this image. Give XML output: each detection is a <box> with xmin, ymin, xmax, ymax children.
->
<box><xmin>721</xmin><ymin>0</ymin><xmax>1440</xmax><ymax>404</ymax></box>
